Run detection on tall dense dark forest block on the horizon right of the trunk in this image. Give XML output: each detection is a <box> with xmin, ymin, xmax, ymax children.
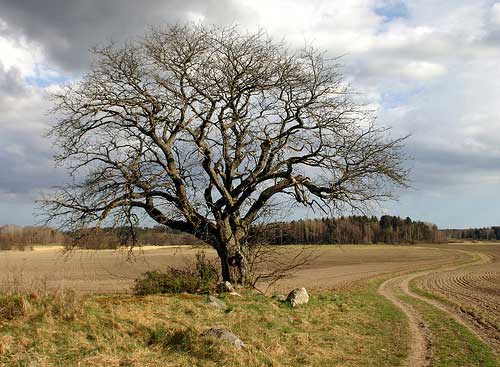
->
<box><xmin>253</xmin><ymin>215</ymin><xmax>446</xmax><ymax>244</ymax></box>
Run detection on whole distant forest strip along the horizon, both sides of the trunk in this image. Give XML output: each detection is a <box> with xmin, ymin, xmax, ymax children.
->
<box><xmin>0</xmin><ymin>215</ymin><xmax>500</xmax><ymax>250</ymax></box>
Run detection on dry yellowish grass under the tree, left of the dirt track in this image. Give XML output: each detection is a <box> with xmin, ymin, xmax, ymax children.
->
<box><xmin>0</xmin><ymin>282</ymin><xmax>408</xmax><ymax>367</ymax></box>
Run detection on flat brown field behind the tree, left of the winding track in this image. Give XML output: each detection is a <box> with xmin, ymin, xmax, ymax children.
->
<box><xmin>0</xmin><ymin>245</ymin><xmax>467</xmax><ymax>293</ymax></box>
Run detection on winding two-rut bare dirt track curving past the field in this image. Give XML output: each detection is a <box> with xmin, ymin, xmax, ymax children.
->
<box><xmin>379</xmin><ymin>250</ymin><xmax>491</xmax><ymax>367</ymax></box>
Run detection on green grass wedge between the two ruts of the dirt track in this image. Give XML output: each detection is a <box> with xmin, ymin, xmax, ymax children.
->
<box><xmin>400</xmin><ymin>295</ymin><xmax>500</xmax><ymax>367</ymax></box>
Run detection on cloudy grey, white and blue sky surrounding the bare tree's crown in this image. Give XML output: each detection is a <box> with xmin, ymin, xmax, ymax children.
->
<box><xmin>0</xmin><ymin>0</ymin><xmax>500</xmax><ymax>228</ymax></box>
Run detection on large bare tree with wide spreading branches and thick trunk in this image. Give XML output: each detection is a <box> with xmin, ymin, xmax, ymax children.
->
<box><xmin>42</xmin><ymin>25</ymin><xmax>407</xmax><ymax>283</ymax></box>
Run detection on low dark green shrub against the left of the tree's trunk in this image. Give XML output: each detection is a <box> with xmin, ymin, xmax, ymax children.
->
<box><xmin>133</xmin><ymin>251</ymin><xmax>219</xmax><ymax>295</ymax></box>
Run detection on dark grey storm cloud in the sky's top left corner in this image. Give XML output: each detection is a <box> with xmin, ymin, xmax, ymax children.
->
<box><xmin>0</xmin><ymin>0</ymin><xmax>246</xmax><ymax>71</ymax></box>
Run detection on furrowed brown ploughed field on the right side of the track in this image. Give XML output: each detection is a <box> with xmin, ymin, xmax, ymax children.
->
<box><xmin>417</xmin><ymin>244</ymin><xmax>500</xmax><ymax>353</ymax></box>
